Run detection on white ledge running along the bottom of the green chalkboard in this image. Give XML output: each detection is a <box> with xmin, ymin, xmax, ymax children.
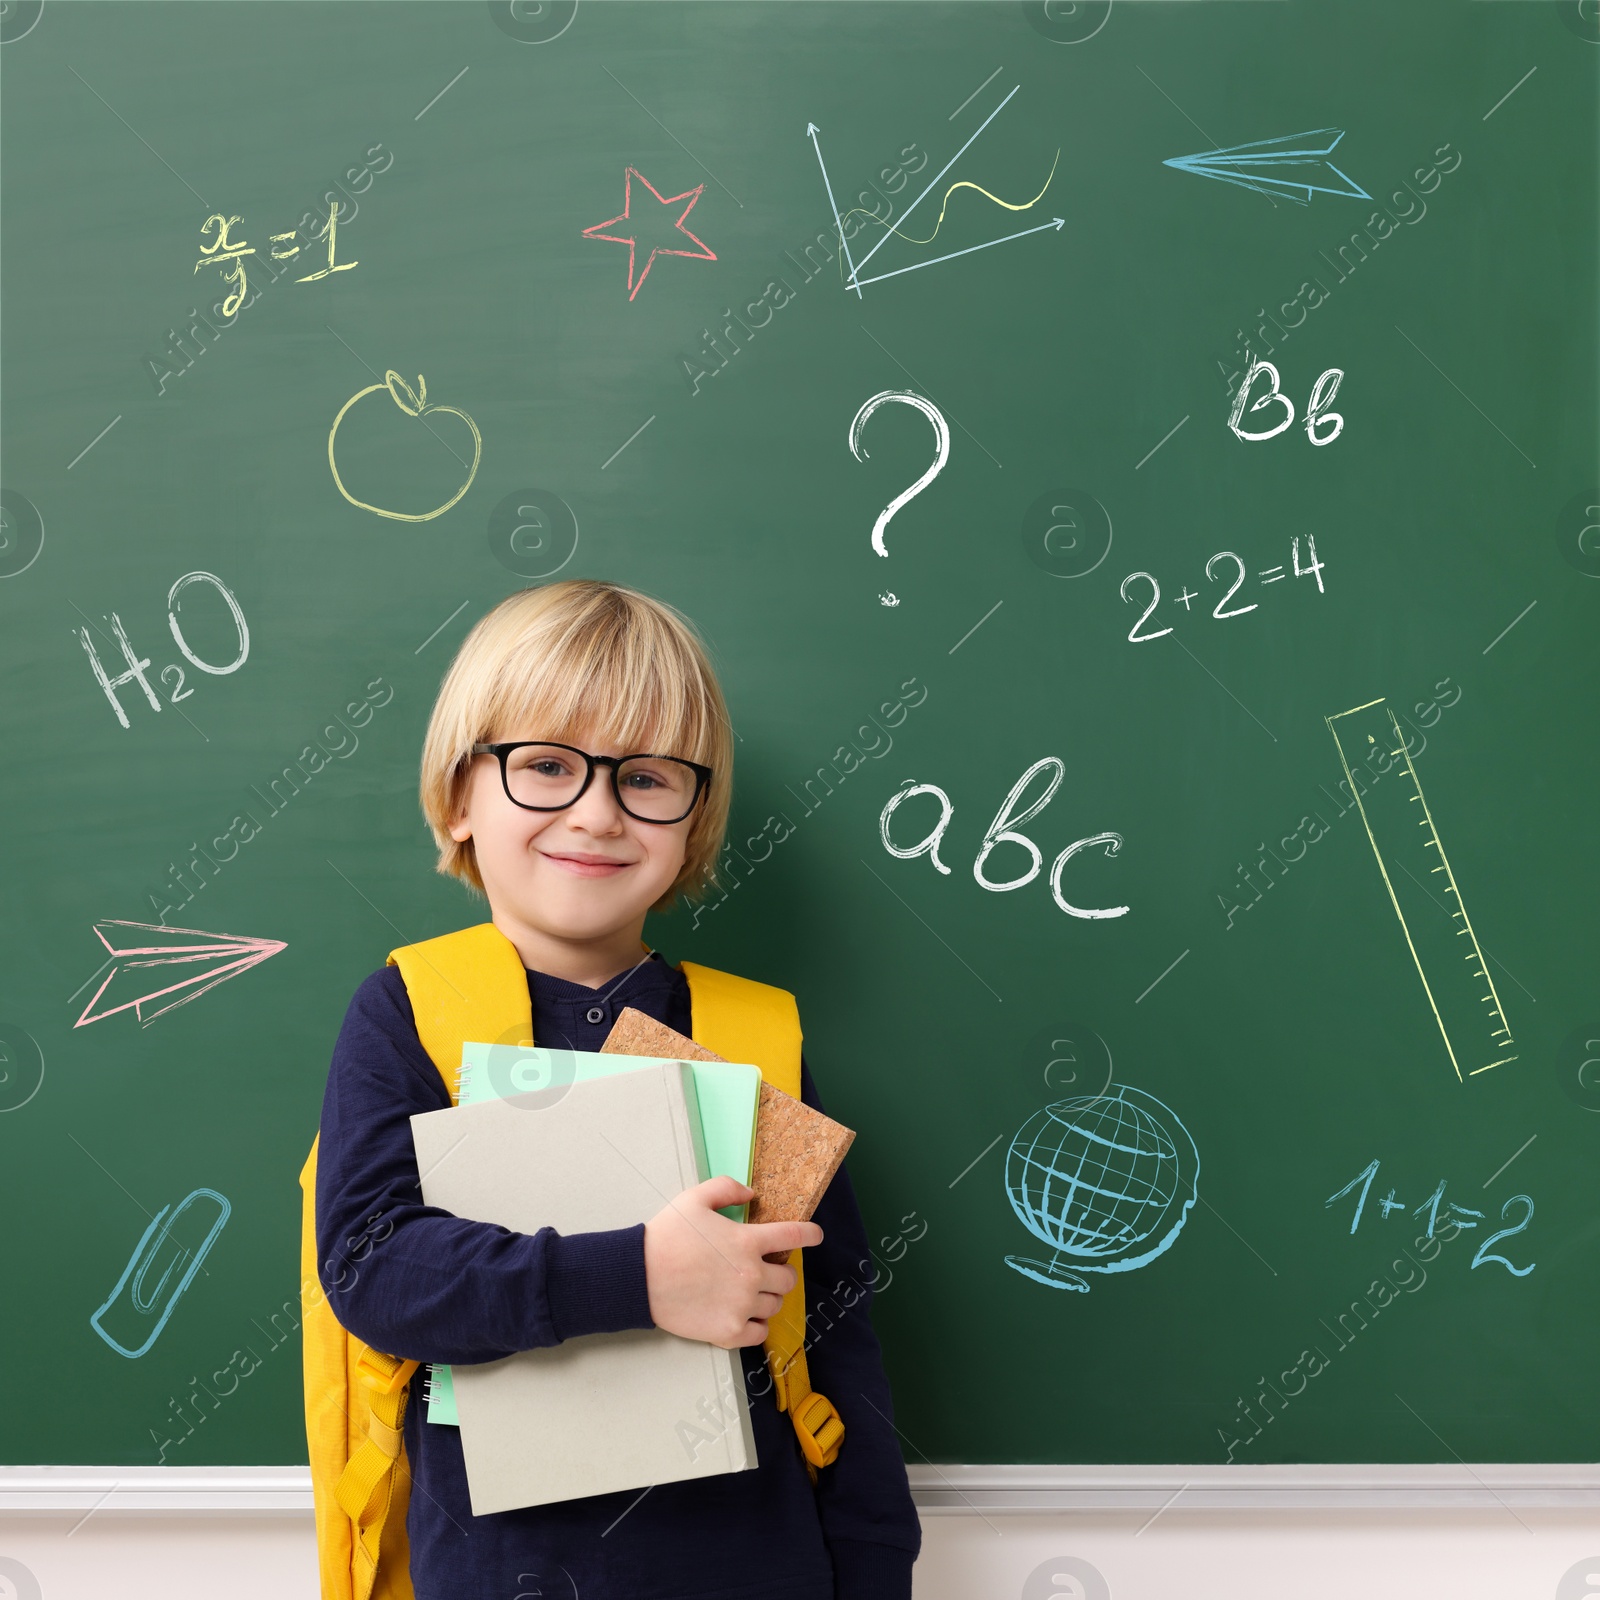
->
<box><xmin>0</xmin><ymin>1462</ymin><xmax>1600</xmax><ymax>1517</ymax></box>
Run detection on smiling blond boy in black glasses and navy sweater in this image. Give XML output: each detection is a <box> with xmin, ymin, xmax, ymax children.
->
<box><xmin>307</xmin><ymin>581</ymin><xmax>922</xmax><ymax>1600</ymax></box>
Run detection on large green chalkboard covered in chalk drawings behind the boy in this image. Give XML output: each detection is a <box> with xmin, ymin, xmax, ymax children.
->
<box><xmin>0</xmin><ymin>0</ymin><xmax>1600</xmax><ymax>1466</ymax></box>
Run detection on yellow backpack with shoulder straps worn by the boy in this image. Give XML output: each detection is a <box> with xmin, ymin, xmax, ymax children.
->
<box><xmin>301</xmin><ymin>922</ymin><xmax>845</xmax><ymax>1600</ymax></box>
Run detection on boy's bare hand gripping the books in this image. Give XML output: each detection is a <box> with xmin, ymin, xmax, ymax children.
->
<box><xmin>645</xmin><ymin>1178</ymin><xmax>822</xmax><ymax>1350</ymax></box>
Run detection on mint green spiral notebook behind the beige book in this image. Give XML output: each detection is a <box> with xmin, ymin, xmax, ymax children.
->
<box><xmin>424</xmin><ymin>1040</ymin><xmax>762</xmax><ymax>1427</ymax></box>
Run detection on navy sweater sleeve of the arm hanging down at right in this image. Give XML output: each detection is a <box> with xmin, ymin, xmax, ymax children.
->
<box><xmin>800</xmin><ymin>1062</ymin><xmax>922</xmax><ymax>1600</ymax></box>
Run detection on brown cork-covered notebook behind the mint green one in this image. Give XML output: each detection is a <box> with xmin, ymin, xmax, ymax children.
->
<box><xmin>600</xmin><ymin>1006</ymin><xmax>856</xmax><ymax>1262</ymax></box>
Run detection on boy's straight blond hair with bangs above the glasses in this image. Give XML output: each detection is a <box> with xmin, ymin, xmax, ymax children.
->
<box><xmin>421</xmin><ymin>578</ymin><xmax>733</xmax><ymax>910</ymax></box>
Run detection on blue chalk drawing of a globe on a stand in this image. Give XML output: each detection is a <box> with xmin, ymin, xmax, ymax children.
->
<box><xmin>1005</xmin><ymin>1083</ymin><xmax>1200</xmax><ymax>1293</ymax></box>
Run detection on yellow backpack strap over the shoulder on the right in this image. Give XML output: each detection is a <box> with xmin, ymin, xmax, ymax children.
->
<box><xmin>682</xmin><ymin>962</ymin><xmax>845</xmax><ymax>1483</ymax></box>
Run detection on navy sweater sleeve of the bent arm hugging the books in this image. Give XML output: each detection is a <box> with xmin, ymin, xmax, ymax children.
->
<box><xmin>317</xmin><ymin>966</ymin><xmax>654</xmax><ymax>1363</ymax></box>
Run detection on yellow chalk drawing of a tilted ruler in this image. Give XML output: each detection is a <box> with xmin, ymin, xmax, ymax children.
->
<box><xmin>1323</xmin><ymin>699</ymin><xmax>1517</xmax><ymax>1082</ymax></box>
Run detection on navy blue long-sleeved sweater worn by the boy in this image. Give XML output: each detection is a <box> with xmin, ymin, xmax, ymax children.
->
<box><xmin>317</xmin><ymin>957</ymin><xmax>922</xmax><ymax>1600</ymax></box>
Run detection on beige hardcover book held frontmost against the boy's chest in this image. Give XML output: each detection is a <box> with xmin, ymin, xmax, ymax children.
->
<box><xmin>411</xmin><ymin>1061</ymin><xmax>758</xmax><ymax>1517</ymax></box>
